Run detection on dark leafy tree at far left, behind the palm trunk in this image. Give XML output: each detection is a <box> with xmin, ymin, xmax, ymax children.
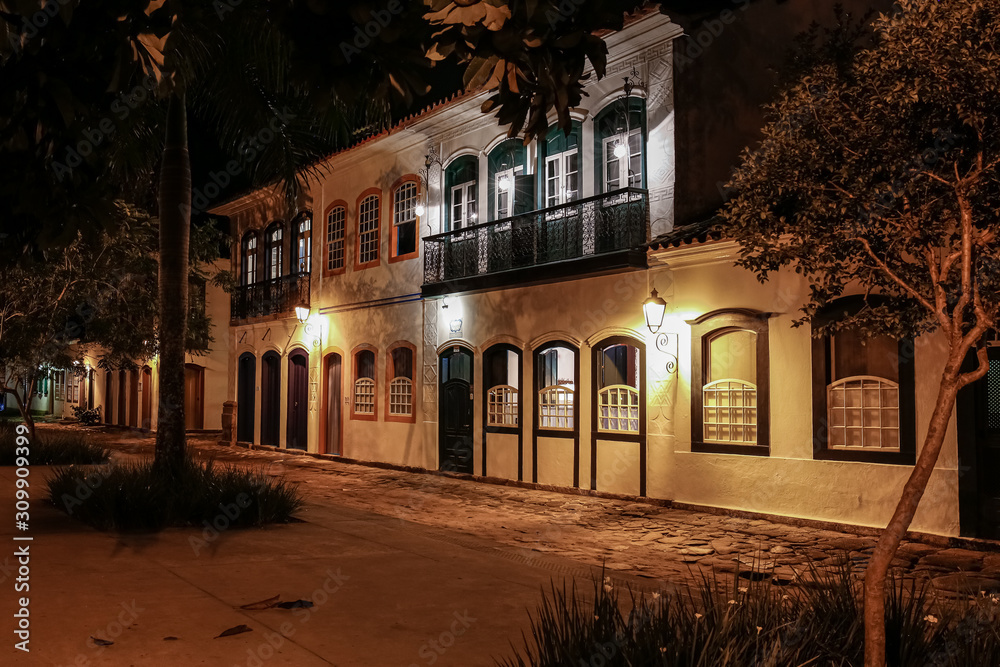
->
<box><xmin>0</xmin><ymin>201</ymin><xmax>225</xmax><ymax>434</ymax></box>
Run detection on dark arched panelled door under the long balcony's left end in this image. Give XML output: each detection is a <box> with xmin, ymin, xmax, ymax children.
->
<box><xmin>438</xmin><ymin>345</ymin><xmax>473</xmax><ymax>474</ymax></box>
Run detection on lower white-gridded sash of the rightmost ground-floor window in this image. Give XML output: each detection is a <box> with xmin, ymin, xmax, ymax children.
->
<box><xmin>827</xmin><ymin>376</ymin><xmax>899</xmax><ymax>451</ymax></box>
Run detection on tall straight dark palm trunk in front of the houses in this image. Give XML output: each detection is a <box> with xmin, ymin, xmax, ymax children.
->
<box><xmin>155</xmin><ymin>93</ymin><xmax>191</xmax><ymax>475</ymax></box>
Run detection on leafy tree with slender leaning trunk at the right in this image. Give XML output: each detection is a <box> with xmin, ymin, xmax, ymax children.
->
<box><xmin>724</xmin><ymin>0</ymin><xmax>1000</xmax><ymax>667</ymax></box>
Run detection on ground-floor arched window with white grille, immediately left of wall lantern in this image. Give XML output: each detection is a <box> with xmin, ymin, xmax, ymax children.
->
<box><xmin>595</xmin><ymin>343</ymin><xmax>642</xmax><ymax>434</ymax></box>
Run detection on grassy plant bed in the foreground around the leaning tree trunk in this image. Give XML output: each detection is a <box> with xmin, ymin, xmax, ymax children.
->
<box><xmin>496</xmin><ymin>565</ymin><xmax>1000</xmax><ymax>667</ymax></box>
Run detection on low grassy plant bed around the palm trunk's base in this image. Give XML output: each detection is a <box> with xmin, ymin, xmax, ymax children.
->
<box><xmin>49</xmin><ymin>459</ymin><xmax>302</xmax><ymax>532</ymax></box>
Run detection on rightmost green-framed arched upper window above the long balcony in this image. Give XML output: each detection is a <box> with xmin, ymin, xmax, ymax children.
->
<box><xmin>594</xmin><ymin>97</ymin><xmax>646</xmax><ymax>192</ymax></box>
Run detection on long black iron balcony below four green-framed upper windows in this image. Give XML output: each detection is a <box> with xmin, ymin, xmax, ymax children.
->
<box><xmin>422</xmin><ymin>188</ymin><xmax>649</xmax><ymax>296</ymax></box>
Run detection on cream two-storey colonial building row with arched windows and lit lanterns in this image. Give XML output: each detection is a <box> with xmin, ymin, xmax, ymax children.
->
<box><xmin>213</xmin><ymin>3</ymin><xmax>1000</xmax><ymax>537</ymax></box>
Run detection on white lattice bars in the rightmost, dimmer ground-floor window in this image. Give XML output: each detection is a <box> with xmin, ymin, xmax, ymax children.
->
<box><xmin>826</xmin><ymin>375</ymin><xmax>902</xmax><ymax>452</ymax></box>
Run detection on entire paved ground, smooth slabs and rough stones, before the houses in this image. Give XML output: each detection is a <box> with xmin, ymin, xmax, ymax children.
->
<box><xmin>0</xmin><ymin>431</ymin><xmax>1000</xmax><ymax>667</ymax></box>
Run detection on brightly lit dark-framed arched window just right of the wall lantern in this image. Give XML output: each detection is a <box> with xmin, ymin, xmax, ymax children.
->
<box><xmin>689</xmin><ymin>309</ymin><xmax>770</xmax><ymax>455</ymax></box>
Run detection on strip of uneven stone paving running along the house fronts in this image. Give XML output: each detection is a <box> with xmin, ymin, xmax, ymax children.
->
<box><xmin>54</xmin><ymin>426</ymin><xmax>1000</xmax><ymax>595</ymax></box>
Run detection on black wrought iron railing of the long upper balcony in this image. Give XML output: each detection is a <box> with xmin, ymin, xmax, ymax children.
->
<box><xmin>424</xmin><ymin>188</ymin><xmax>649</xmax><ymax>285</ymax></box>
